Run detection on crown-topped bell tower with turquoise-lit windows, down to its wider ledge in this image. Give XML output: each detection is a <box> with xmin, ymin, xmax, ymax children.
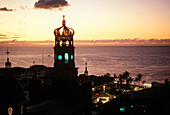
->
<box><xmin>54</xmin><ymin>15</ymin><xmax>75</xmax><ymax>68</ymax></box>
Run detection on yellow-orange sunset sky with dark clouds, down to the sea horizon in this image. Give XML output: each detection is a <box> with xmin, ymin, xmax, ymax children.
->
<box><xmin>0</xmin><ymin>0</ymin><xmax>170</xmax><ymax>47</ymax></box>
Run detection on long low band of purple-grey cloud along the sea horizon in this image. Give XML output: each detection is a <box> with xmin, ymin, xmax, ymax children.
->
<box><xmin>0</xmin><ymin>38</ymin><xmax>170</xmax><ymax>47</ymax></box>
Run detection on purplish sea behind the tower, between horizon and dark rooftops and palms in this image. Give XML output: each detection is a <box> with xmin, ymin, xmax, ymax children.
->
<box><xmin>0</xmin><ymin>46</ymin><xmax>170</xmax><ymax>83</ymax></box>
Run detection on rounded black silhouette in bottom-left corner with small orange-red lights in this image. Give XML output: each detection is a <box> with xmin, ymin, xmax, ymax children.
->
<box><xmin>0</xmin><ymin>68</ymin><xmax>26</xmax><ymax>115</ymax></box>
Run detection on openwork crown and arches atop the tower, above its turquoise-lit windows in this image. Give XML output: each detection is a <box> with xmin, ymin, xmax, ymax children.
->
<box><xmin>54</xmin><ymin>15</ymin><xmax>74</xmax><ymax>47</ymax></box>
